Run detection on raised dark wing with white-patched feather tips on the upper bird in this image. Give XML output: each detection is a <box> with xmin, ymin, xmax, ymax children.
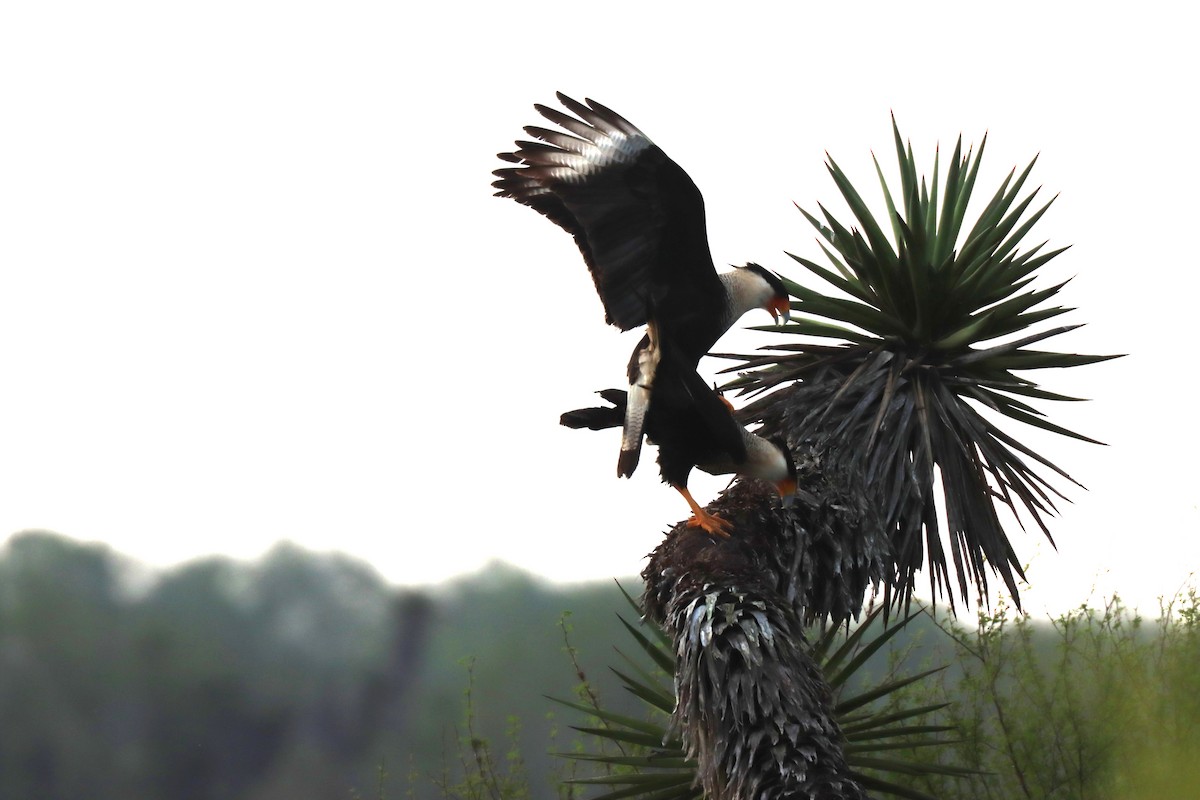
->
<box><xmin>492</xmin><ymin>92</ymin><xmax>724</xmax><ymax>330</ymax></box>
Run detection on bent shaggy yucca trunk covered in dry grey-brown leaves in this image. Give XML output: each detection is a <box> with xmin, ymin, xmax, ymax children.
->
<box><xmin>642</xmin><ymin>479</ymin><xmax>886</xmax><ymax>800</ymax></box>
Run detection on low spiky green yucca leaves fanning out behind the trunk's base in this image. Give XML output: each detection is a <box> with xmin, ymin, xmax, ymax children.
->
<box><xmin>556</xmin><ymin>587</ymin><xmax>973</xmax><ymax>800</ymax></box>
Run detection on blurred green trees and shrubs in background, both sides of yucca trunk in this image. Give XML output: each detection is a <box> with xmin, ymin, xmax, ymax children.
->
<box><xmin>0</xmin><ymin>533</ymin><xmax>1200</xmax><ymax>800</ymax></box>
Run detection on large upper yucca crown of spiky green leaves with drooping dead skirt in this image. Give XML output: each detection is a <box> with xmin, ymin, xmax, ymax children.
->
<box><xmin>730</xmin><ymin>120</ymin><xmax>1116</xmax><ymax>603</ymax></box>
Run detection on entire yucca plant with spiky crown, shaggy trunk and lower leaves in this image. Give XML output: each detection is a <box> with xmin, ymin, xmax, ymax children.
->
<box><xmin>552</xmin><ymin>121</ymin><xmax>1115</xmax><ymax>800</ymax></box>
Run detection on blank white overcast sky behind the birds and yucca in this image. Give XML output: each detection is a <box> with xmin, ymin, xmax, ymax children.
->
<box><xmin>0</xmin><ymin>0</ymin><xmax>1200</xmax><ymax>608</ymax></box>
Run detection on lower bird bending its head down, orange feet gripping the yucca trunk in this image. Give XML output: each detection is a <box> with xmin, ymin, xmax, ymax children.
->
<box><xmin>559</xmin><ymin>357</ymin><xmax>796</xmax><ymax>536</ymax></box>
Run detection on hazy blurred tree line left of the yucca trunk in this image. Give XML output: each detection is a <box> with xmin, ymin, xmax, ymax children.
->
<box><xmin>0</xmin><ymin>533</ymin><xmax>638</xmax><ymax>800</ymax></box>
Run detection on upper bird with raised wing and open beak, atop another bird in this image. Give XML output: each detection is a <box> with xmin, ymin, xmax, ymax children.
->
<box><xmin>492</xmin><ymin>92</ymin><xmax>790</xmax><ymax>476</ymax></box>
